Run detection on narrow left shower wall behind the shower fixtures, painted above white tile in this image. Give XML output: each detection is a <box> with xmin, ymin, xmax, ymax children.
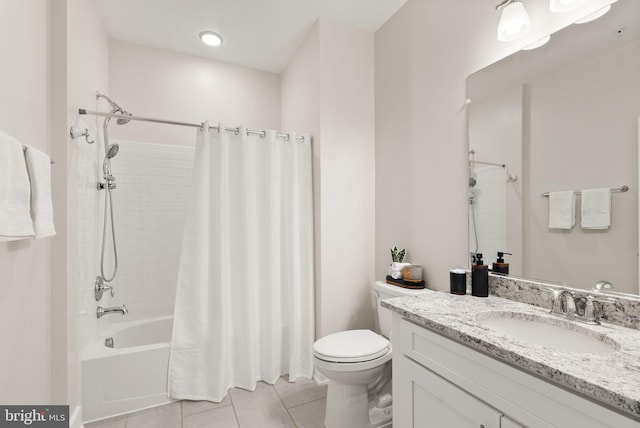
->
<box><xmin>67</xmin><ymin>0</ymin><xmax>109</xmax><ymax>413</ymax></box>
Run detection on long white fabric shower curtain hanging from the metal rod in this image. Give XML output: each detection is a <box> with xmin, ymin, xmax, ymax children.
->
<box><xmin>168</xmin><ymin>122</ymin><xmax>314</xmax><ymax>402</ymax></box>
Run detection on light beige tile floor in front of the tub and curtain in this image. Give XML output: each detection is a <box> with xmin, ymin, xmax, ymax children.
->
<box><xmin>85</xmin><ymin>377</ymin><xmax>327</xmax><ymax>428</ymax></box>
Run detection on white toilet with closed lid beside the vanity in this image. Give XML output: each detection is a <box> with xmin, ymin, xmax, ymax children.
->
<box><xmin>313</xmin><ymin>281</ymin><xmax>424</xmax><ymax>428</ymax></box>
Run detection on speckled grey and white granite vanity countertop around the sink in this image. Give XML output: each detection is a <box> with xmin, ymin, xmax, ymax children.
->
<box><xmin>382</xmin><ymin>291</ymin><xmax>640</xmax><ymax>420</ymax></box>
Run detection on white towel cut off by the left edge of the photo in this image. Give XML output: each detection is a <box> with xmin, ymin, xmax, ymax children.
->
<box><xmin>0</xmin><ymin>132</ymin><xmax>34</xmax><ymax>241</ymax></box>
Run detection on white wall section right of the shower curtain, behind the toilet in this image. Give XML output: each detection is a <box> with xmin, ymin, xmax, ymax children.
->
<box><xmin>282</xmin><ymin>19</ymin><xmax>375</xmax><ymax>337</ymax></box>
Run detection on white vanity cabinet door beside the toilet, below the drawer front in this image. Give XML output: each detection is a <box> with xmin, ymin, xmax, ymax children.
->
<box><xmin>394</xmin><ymin>356</ymin><xmax>502</xmax><ymax>428</ymax></box>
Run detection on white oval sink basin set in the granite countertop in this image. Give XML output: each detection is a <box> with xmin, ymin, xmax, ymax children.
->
<box><xmin>477</xmin><ymin>311</ymin><xmax>620</xmax><ymax>354</ymax></box>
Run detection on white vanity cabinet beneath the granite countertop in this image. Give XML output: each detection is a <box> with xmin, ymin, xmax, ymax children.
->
<box><xmin>392</xmin><ymin>312</ymin><xmax>640</xmax><ymax>428</ymax></box>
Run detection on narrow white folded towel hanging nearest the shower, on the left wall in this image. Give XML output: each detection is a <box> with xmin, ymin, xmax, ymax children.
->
<box><xmin>24</xmin><ymin>145</ymin><xmax>56</xmax><ymax>239</ymax></box>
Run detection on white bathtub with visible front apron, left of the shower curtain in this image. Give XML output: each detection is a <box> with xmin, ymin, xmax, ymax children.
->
<box><xmin>82</xmin><ymin>317</ymin><xmax>173</xmax><ymax>422</ymax></box>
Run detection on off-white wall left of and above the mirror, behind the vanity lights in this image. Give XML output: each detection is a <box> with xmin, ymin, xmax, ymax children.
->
<box><xmin>376</xmin><ymin>0</ymin><xmax>611</xmax><ymax>289</ymax></box>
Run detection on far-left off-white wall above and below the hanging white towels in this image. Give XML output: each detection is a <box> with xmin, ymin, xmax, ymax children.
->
<box><xmin>0</xmin><ymin>0</ymin><xmax>53</xmax><ymax>404</ymax></box>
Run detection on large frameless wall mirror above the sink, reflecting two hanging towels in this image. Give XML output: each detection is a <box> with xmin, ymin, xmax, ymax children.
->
<box><xmin>467</xmin><ymin>0</ymin><xmax>640</xmax><ymax>294</ymax></box>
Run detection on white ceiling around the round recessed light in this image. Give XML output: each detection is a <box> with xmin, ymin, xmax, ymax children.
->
<box><xmin>97</xmin><ymin>0</ymin><xmax>407</xmax><ymax>73</ymax></box>
